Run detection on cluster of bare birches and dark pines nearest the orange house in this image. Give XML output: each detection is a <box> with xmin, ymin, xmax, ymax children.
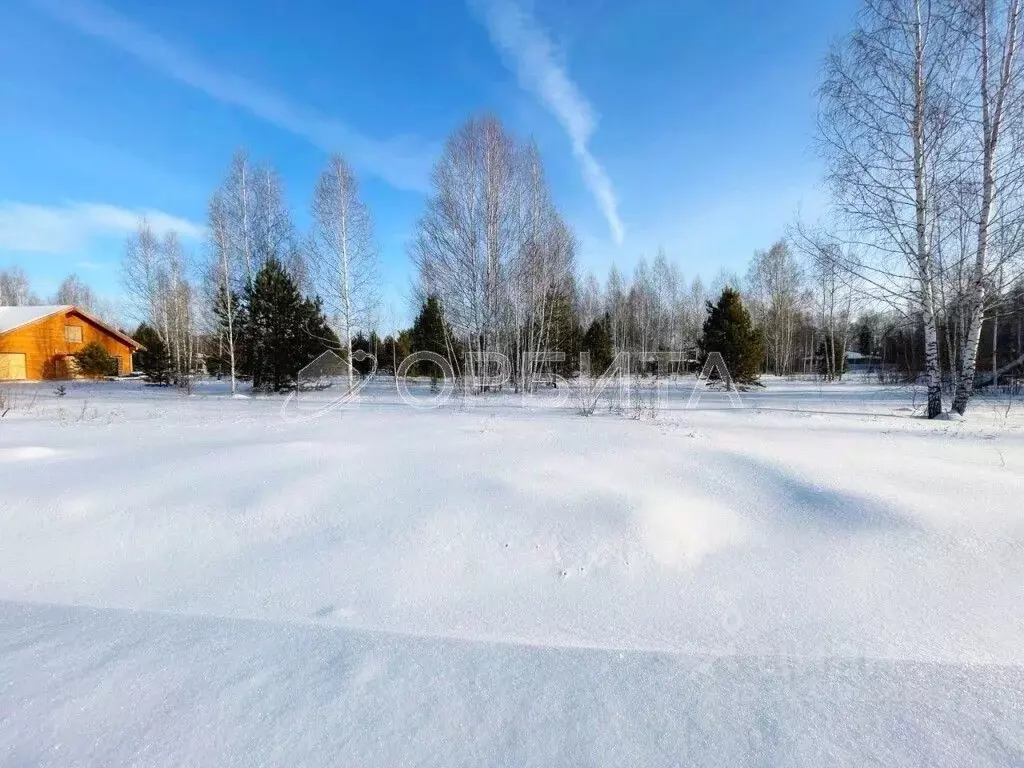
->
<box><xmin>116</xmin><ymin>151</ymin><xmax>377</xmax><ymax>393</ymax></box>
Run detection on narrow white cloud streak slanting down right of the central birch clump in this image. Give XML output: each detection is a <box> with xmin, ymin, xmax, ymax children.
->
<box><xmin>470</xmin><ymin>0</ymin><xmax>625</xmax><ymax>245</ymax></box>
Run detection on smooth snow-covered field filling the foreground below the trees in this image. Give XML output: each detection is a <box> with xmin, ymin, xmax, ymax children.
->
<box><xmin>0</xmin><ymin>381</ymin><xmax>1024</xmax><ymax>768</ymax></box>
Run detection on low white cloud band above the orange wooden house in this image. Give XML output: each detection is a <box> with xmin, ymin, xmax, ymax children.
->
<box><xmin>0</xmin><ymin>201</ymin><xmax>204</xmax><ymax>255</ymax></box>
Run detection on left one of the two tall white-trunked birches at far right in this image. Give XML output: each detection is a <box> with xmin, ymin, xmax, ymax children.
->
<box><xmin>820</xmin><ymin>0</ymin><xmax>958</xmax><ymax>418</ymax></box>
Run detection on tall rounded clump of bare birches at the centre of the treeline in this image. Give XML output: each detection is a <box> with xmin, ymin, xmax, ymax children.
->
<box><xmin>411</xmin><ymin>116</ymin><xmax>585</xmax><ymax>391</ymax></box>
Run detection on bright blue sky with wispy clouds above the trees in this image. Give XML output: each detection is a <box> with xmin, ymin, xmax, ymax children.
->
<box><xmin>0</xmin><ymin>0</ymin><xmax>856</xmax><ymax>324</ymax></box>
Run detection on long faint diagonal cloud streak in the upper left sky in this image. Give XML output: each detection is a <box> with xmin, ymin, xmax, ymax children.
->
<box><xmin>31</xmin><ymin>0</ymin><xmax>436</xmax><ymax>190</ymax></box>
